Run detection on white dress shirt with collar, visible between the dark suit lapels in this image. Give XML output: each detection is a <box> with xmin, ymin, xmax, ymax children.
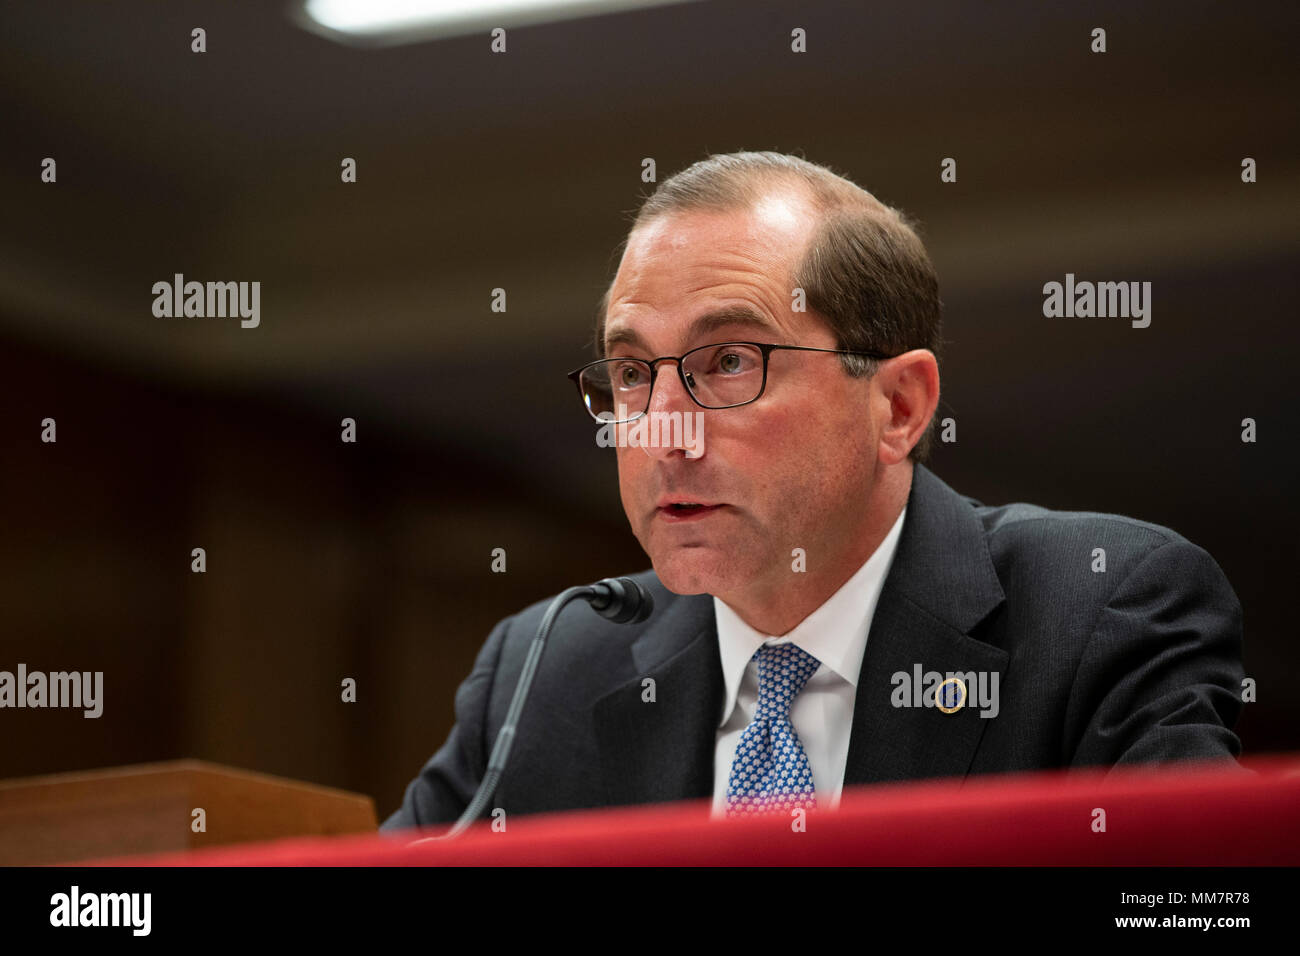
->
<box><xmin>712</xmin><ymin>507</ymin><xmax>907</xmax><ymax>817</ymax></box>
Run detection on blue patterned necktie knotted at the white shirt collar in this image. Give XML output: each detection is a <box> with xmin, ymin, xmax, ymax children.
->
<box><xmin>727</xmin><ymin>644</ymin><xmax>822</xmax><ymax>817</ymax></box>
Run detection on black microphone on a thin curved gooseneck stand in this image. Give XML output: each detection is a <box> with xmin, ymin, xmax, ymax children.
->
<box><xmin>431</xmin><ymin>578</ymin><xmax>654</xmax><ymax>843</ymax></box>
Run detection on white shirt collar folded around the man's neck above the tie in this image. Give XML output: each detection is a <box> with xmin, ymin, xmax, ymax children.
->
<box><xmin>714</xmin><ymin>506</ymin><xmax>907</xmax><ymax>726</ymax></box>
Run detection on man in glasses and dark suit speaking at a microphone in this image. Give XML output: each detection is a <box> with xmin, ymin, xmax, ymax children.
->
<box><xmin>384</xmin><ymin>153</ymin><xmax>1243</xmax><ymax>830</ymax></box>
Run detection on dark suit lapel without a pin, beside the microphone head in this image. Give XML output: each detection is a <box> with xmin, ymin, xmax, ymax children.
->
<box><xmin>593</xmin><ymin>598</ymin><xmax>723</xmax><ymax>805</ymax></box>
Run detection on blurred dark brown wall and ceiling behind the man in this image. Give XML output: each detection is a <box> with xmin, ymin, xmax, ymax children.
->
<box><xmin>0</xmin><ymin>0</ymin><xmax>1300</xmax><ymax>814</ymax></box>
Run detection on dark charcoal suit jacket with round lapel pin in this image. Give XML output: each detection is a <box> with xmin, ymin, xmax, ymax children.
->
<box><xmin>381</xmin><ymin>466</ymin><xmax>1243</xmax><ymax>830</ymax></box>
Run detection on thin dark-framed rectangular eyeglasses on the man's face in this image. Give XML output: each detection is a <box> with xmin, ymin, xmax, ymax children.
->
<box><xmin>568</xmin><ymin>342</ymin><xmax>894</xmax><ymax>424</ymax></box>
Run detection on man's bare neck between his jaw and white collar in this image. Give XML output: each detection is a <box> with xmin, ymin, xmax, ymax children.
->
<box><xmin>718</xmin><ymin>460</ymin><xmax>914</xmax><ymax>637</ymax></box>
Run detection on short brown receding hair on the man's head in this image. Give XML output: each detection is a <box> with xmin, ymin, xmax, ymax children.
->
<box><xmin>595</xmin><ymin>152</ymin><xmax>943</xmax><ymax>463</ymax></box>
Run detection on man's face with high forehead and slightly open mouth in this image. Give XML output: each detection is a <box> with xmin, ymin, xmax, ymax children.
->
<box><xmin>605</xmin><ymin>193</ymin><xmax>888</xmax><ymax>604</ymax></box>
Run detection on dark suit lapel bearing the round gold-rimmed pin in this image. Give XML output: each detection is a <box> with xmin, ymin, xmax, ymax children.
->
<box><xmin>844</xmin><ymin>464</ymin><xmax>1008</xmax><ymax>786</ymax></box>
